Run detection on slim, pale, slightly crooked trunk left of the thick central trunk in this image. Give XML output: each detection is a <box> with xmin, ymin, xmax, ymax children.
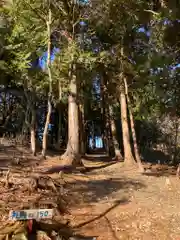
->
<box><xmin>42</xmin><ymin>9</ymin><xmax>52</xmax><ymax>158</ymax></box>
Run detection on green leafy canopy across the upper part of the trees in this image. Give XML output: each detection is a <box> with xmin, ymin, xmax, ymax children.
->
<box><xmin>0</xmin><ymin>0</ymin><xmax>180</xmax><ymax>124</ymax></box>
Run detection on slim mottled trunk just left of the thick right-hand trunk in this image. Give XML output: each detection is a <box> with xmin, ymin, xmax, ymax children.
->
<box><xmin>109</xmin><ymin>106</ymin><xmax>123</xmax><ymax>160</ymax></box>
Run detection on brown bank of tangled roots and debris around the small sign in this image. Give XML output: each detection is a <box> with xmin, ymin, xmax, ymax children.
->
<box><xmin>0</xmin><ymin>172</ymin><xmax>72</xmax><ymax>240</ymax></box>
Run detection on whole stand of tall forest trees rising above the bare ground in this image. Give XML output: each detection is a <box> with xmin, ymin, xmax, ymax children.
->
<box><xmin>0</xmin><ymin>0</ymin><xmax>180</xmax><ymax>170</ymax></box>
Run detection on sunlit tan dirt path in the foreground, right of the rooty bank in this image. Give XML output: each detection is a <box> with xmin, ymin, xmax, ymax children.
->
<box><xmin>34</xmin><ymin>158</ymin><xmax>180</xmax><ymax>240</ymax></box>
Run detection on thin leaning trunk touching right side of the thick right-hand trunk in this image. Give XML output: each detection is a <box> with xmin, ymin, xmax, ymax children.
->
<box><xmin>124</xmin><ymin>78</ymin><xmax>144</xmax><ymax>172</ymax></box>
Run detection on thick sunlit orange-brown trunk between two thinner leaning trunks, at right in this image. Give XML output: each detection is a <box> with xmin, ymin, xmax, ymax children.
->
<box><xmin>120</xmin><ymin>87</ymin><xmax>135</xmax><ymax>165</ymax></box>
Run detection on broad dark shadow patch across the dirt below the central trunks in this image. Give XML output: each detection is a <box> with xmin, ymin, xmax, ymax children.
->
<box><xmin>65</xmin><ymin>177</ymin><xmax>146</xmax><ymax>205</ymax></box>
